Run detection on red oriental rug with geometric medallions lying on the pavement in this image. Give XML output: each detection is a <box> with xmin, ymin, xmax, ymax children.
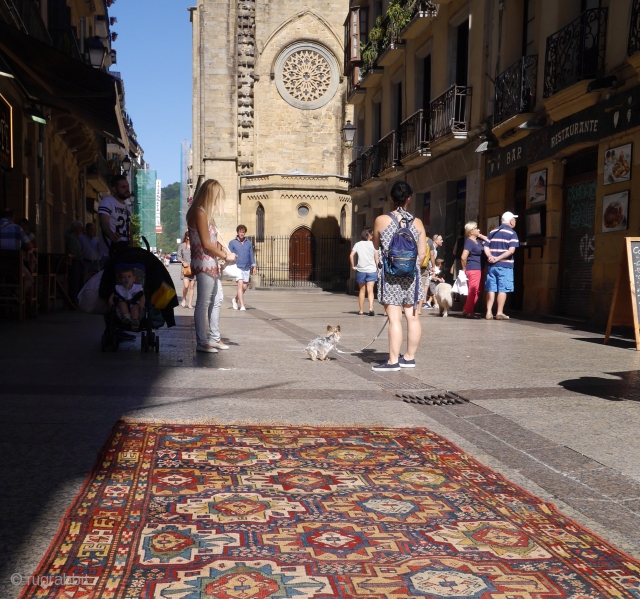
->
<box><xmin>17</xmin><ymin>422</ymin><xmax>640</xmax><ymax>599</ymax></box>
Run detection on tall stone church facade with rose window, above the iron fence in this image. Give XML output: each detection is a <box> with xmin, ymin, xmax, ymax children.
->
<box><xmin>190</xmin><ymin>0</ymin><xmax>351</xmax><ymax>248</ymax></box>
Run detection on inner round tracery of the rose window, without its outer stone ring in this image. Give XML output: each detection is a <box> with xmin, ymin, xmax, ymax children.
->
<box><xmin>282</xmin><ymin>50</ymin><xmax>331</xmax><ymax>102</ymax></box>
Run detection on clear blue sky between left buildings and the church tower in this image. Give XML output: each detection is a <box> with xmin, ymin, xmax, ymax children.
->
<box><xmin>109</xmin><ymin>0</ymin><xmax>195</xmax><ymax>186</ymax></box>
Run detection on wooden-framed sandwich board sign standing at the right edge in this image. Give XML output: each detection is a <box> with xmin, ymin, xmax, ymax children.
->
<box><xmin>604</xmin><ymin>237</ymin><xmax>640</xmax><ymax>351</ymax></box>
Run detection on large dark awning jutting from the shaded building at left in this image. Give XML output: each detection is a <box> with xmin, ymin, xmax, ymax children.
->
<box><xmin>0</xmin><ymin>20</ymin><xmax>126</xmax><ymax>143</ymax></box>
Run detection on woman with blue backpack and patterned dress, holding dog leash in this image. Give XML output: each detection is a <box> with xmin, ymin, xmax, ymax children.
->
<box><xmin>372</xmin><ymin>181</ymin><xmax>426</xmax><ymax>372</ymax></box>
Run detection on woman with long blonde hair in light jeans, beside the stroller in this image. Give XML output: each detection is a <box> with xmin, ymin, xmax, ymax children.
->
<box><xmin>187</xmin><ymin>179</ymin><xmax>236</xmax><ymax>354</ymax></box>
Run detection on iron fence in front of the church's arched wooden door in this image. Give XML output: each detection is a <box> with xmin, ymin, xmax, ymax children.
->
<box><xmin>249</xmin><ymin>236</ymin><xmax>351</xmax><ymax>290</ymax></box>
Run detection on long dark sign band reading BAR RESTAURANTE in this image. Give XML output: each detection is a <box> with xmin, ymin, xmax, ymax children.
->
<box><xmin>486</xmin><ymin>87</ymin><xmax>640</xmax><ymax>179</ymax></box>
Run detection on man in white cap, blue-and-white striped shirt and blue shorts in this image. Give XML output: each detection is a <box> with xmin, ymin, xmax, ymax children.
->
<box><xmin>483</xmin><ymin>212</ymin><xmax>520</xmax><ymax>320</ymax></box>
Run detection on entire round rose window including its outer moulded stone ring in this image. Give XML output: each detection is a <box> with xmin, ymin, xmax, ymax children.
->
<box><xmin>275</xmin><ymin>42</ymin><xmax>340</xmax><ymax>110</ymax></box>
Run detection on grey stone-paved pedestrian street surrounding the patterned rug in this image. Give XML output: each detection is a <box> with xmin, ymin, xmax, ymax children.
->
<box><xmin>0</xmin><ymin>265</ymin><xmax>640</xmax><ymax>599</ymax></box>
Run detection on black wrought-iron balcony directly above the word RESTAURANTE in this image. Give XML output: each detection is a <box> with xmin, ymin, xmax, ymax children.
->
<box><xmin>544</xmin><ymin>8</ymin><xmax>608</xmax><ymax>98</ymax></box>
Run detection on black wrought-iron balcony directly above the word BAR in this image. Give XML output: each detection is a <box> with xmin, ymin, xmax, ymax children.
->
<box><xmin>493</xmin><ymin>56</ymin><xmax>538</xmax><ymax>125</ymax></box>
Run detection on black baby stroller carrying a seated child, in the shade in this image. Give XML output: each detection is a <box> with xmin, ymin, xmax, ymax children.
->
<box><xmin>99</xmin><ymin>240</ymin><xmax>178</xmax><ymax>353</ymax></box>
